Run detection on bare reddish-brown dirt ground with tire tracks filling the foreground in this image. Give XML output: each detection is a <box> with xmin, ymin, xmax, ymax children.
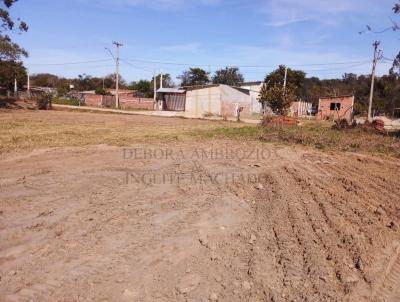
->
<box><xmin>0</xmin><ymin>109</ymin><xmax>400</xmax><ymax>301</ymax></box>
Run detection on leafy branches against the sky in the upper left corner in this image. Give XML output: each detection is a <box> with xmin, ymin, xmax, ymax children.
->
<box><xmin>0</xmin><ymin>0</ymin><xmax>28</xmax><ymax>61</ymax></box>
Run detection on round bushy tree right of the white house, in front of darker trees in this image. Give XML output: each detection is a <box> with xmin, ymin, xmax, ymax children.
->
<box><xmin>260</xmin><ymin>84</ymin><xmax>296</xmax><ymax>115</ymax></box>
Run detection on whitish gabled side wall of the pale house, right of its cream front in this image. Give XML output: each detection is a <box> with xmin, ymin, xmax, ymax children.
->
<box><xmin>220</xmin><ymin>85</ymin><xmax>252</xmax><ymax>118</ymax></box>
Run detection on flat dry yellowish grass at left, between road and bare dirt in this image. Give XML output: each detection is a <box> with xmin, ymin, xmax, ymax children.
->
<box><xmin>0</xmin><ymin>111</ymin><xmax>231</xmax><ymax>153</ymax></box>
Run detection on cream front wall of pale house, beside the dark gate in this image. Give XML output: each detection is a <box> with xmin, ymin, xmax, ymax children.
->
<box><xmin>185</xmin><ymin>86</ymin><xmax>221</xmax><ymax>118</ymax></box>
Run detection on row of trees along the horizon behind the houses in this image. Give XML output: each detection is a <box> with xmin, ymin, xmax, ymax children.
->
<box><xmin>11</xmin><ymin>65</ymin><xmax>400</xmax><ymax>114</ymax></box>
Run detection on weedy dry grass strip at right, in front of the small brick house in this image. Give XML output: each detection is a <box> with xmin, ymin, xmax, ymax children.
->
<box><xmin>192</xmin><ymin>121</ymin><xmax>400</xmax><ymax>158</ymax></box>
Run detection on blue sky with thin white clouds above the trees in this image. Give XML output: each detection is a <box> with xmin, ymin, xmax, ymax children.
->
<box><xmin>8</xmin><ymin>0</ymin><xmax>400</xmax><ymax>82</ymax></box>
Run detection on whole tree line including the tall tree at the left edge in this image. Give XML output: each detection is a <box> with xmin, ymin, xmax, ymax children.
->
<box><xmin>0</xmin><ymin>0</ymin><xmax>400</xmax><ymax>114</ymax></box>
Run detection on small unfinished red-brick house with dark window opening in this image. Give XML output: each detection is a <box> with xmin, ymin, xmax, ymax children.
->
<box><xmin>317</xmin><ymin>95</ymin><xmax>354</xmax><ymax>122</ymax></box>
